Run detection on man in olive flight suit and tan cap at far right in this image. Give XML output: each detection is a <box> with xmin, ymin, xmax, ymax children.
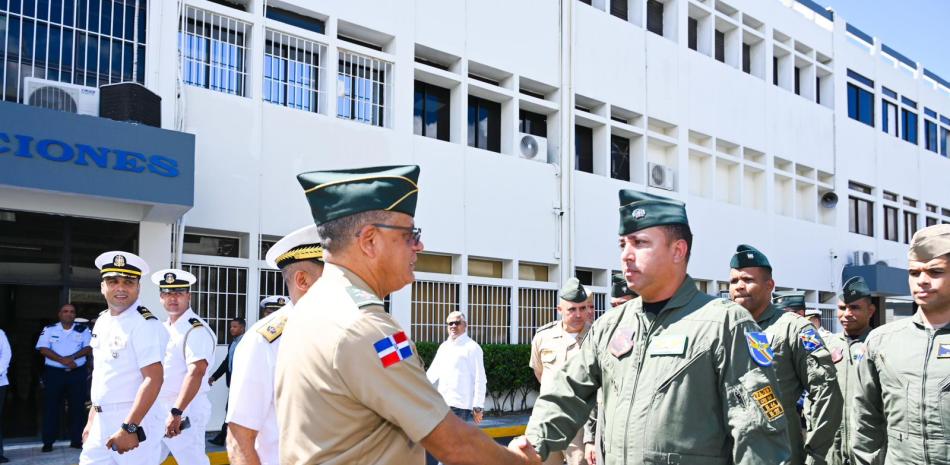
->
<box><xmin>854</xmin><ymin>224</ymin><xmax>950</xmax><ymax>465</ymax></box>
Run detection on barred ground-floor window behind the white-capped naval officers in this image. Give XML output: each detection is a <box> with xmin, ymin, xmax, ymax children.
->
<box><xmin>182</xmin><ymin>263</ymin><xmax>247</xmax><ymax>344</ymax></box>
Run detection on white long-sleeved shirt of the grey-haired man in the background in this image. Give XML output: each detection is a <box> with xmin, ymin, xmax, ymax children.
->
<box><xmin>426</xmin><ymin>334</ymin><xmax>487</xmax><ymax>410</ymax></box>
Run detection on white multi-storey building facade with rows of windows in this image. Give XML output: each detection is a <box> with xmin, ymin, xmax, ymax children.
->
<box><xmin>0</xmin><ymin>0</ymin><xmax>950</xmax><ymax>436</ymax></box>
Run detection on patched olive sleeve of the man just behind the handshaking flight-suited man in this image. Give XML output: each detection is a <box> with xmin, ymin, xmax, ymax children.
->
<box><xmin>792</xmin><ymin>325</ymin><xmax>844</xmax><ymax>464</ymax></box>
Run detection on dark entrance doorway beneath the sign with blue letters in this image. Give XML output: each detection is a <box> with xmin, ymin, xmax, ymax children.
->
<box><xmin>0</xmin><ymin>210</ymin><xmax>139</xmax><ymax>442</ymax></box>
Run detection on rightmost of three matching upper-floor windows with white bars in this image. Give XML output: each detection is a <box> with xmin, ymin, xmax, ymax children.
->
<box><xmin>336</xmin><ymin>49</ymin><xmax>392</xmax><ymax>127</ymax></box>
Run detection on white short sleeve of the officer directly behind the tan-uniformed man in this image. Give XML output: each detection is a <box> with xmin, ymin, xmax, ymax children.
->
<box><xmin>225</xmin><ymin>333</ymin><xmax>275</xmax><ymax>431</ymax></box>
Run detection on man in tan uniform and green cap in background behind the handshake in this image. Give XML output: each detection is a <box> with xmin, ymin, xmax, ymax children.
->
<box><xmin>528</xmin><ymin>278</ymin><xmax>590</xmax><ymax>465</ymax></box>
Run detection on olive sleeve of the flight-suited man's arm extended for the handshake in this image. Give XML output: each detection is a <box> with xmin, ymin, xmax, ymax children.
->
<box><xmin>525</xmin><ymin>331</ymin><xmax>601</xmax><ymax>460</ymax></box>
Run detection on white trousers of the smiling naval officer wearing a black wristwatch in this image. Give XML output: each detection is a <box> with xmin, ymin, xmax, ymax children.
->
<box><xmin>79</xmin><ymin>402</ymin><xmax>165</xmax><ymax>465</ymax></box>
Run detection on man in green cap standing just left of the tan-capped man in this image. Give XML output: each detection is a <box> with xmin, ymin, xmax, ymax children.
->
<box><xmin>825</xmin><ymin>276</ymin><xmax>877</xmax><ymax>465</ymax></box>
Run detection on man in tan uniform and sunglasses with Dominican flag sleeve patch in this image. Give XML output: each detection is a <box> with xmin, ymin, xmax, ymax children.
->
<box><xmin>276</xmin><ymin>166</ymin><xmax>539</xmax><ymax>465</ymax></box>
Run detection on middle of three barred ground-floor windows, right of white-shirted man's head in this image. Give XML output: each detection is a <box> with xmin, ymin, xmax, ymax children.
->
<box><xmin>468</xmin><ymin>284</ymin><xmax>511</xmax><ymax>344</ymax></box>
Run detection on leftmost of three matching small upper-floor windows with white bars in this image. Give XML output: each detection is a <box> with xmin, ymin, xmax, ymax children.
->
<box><xmin>178</xmin><ymin>6</ymin><xmax>251</xmax><ymax>97</ymax></box>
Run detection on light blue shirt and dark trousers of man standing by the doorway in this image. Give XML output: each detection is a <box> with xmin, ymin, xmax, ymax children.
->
<box><xmin>36</xmin><ymin>323</ymin><xmax>92</xmax><ymax>446</ymax></box>
